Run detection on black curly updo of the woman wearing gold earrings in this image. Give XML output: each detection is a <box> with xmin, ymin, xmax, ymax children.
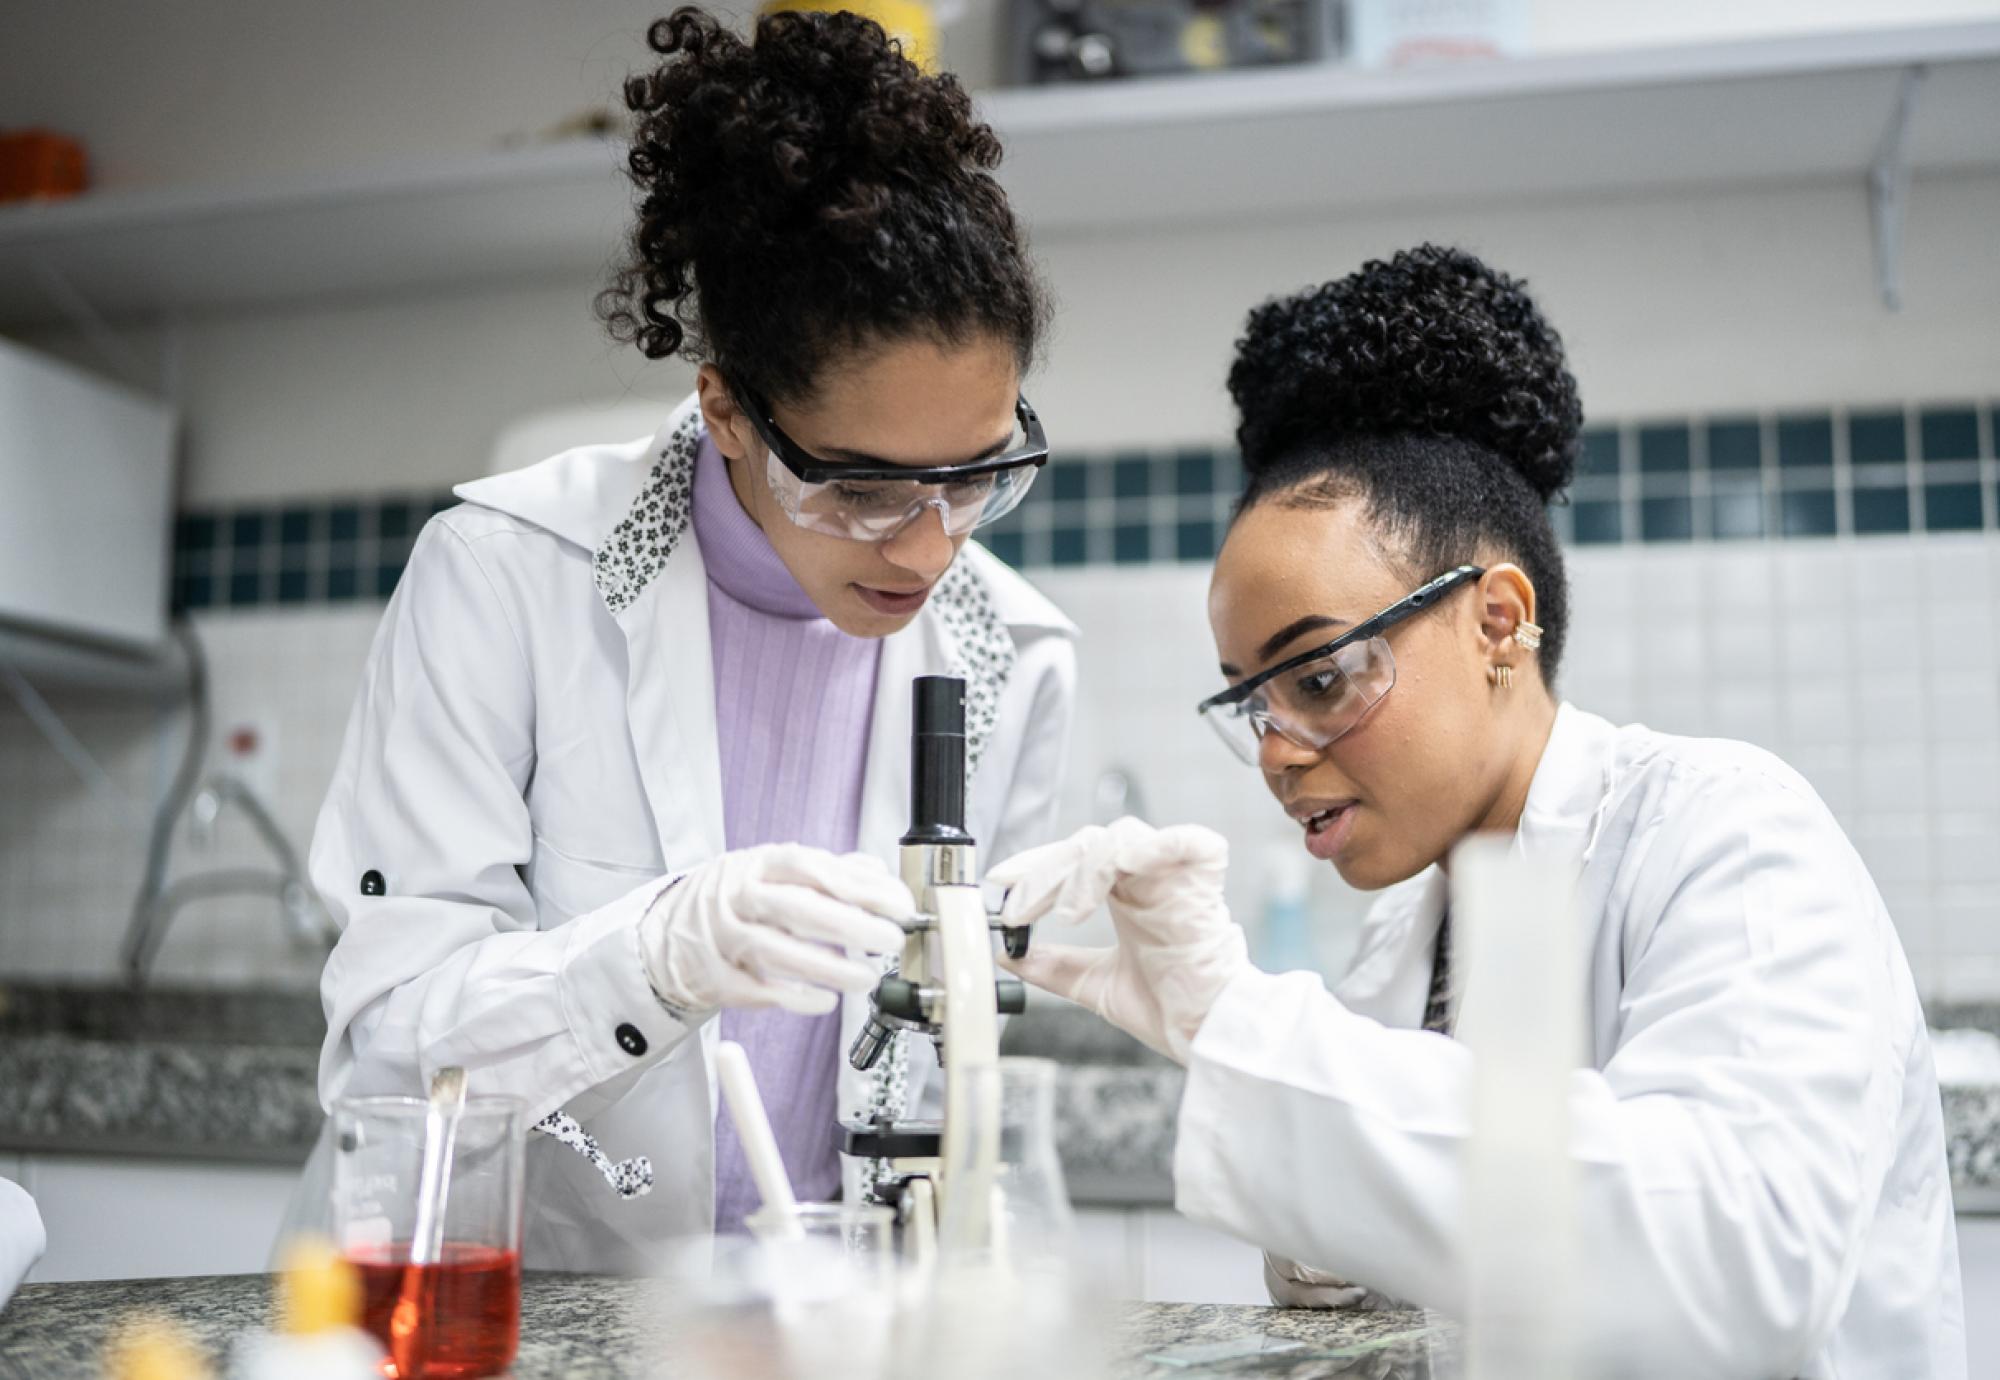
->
<box><xmin>1230</xmin><ymin>244</ymin><xmax>1584</xmax><ymax>686</ymax></box>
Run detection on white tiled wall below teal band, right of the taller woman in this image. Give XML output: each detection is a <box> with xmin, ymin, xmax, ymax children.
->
<box><xmin>1038</xmin><ymin>534</ymin><xmax>2000</xmax><ymax>1000</ymax></box>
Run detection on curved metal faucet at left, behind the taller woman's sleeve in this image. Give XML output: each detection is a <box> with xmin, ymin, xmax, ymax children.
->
<box><xmin>120</xmin><ymin>774</ymin><xmax>336</xmax><ymax>986</ymax></box>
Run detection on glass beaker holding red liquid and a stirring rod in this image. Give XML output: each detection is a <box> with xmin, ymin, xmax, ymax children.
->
<box><xmin>332</xmin><ymin>1098</ymin><xmax>524</xmax><ymax>1380</ymax></box>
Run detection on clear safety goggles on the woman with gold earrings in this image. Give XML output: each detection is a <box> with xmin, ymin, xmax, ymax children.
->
<box><xmin>1196</xmin><ymin>566</ymin><xmax>1486</xmax><ymax>766</ymax></box>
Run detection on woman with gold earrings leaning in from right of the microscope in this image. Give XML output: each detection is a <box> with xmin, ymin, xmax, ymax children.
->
<box><xmin>988</xmin><ymin>246</ymin><xmax>1966</xmax><ymax>1380</ymax></box>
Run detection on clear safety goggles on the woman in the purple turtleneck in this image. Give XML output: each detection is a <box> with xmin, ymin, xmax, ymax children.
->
<box><xmin>742</xmin><ymin>396</ymin><xmax>1048</xmax><ymax>542</ymax></box>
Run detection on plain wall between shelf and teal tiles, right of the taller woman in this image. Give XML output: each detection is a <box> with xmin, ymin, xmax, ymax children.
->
<box><xmin>1036</xmin><ymin>176</ymin><xmax>2000</xmax><ymax>448</ymax></box>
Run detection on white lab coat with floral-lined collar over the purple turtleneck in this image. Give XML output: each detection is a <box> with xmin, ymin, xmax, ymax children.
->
<box><xmin>302</xmin><ymin>398</ymin><xmax>1076</xmax><ymax>1272</ymax></box>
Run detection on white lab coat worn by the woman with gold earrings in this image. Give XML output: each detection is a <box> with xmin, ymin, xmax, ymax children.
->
<box><xmin>1174</xmin><ymin>706</ymin><xmax>1966</xmax><ymax>1380</ymax></box>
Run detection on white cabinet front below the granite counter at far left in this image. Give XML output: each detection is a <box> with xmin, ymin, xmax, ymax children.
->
<box><xmin>16</xmin><ymin>1154</ymin><xmax>298</xmax><ymax>1284</ymax></box>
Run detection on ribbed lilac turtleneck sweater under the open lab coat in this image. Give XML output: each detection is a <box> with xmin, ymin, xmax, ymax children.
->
<box><xmin>694</xmin><ymin>430</ymin><xmax>882</xmax><ymax>1232</ymax></box>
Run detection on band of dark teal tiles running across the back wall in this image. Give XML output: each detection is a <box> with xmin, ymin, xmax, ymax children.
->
<box><xmin>174</xmin><ymin>400</ymin><xmax>2000</xmax><ymax>610</ymax></box>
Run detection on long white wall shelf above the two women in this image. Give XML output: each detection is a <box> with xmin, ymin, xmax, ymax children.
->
<box><xmin>0</xmin><ymin>24</ymin><xmax>2000</xmax><ymax>326</ymax></box>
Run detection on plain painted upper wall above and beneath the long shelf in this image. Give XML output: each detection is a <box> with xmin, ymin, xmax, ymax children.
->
<box><xmin>15</xmin><ymin>0</ymin><xmax>2000</xmax><ymax>506</ymax></box>
